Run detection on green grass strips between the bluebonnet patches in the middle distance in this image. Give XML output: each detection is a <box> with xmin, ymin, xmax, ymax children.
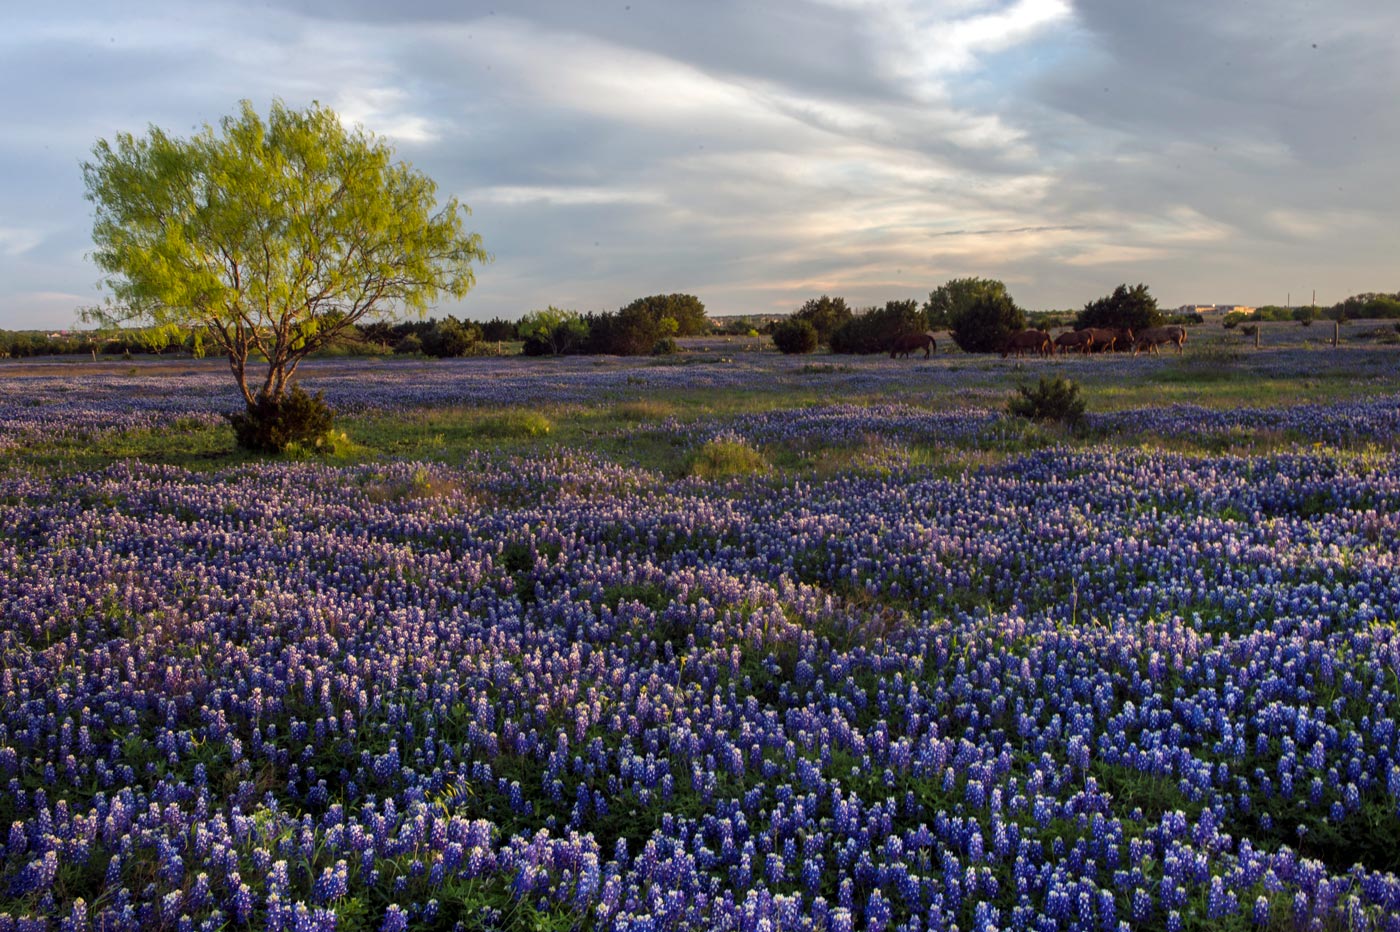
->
<box><xmin>0</xmin><ymin>339</ymin><xmax>1394</xmax><ymax>479</ymax></box>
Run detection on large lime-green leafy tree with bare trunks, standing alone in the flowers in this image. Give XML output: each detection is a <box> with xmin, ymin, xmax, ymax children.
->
<box><xmin>83</xmin><ymin>101</ymin><xmax>489</xmax><ymax>414</ymax></box>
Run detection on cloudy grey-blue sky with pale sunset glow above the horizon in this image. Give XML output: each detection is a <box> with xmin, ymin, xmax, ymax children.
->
<box><xmin>0</xmin><ymin>0</ymin><xmax>1400</xmax><ymax>329</ymax></box>
